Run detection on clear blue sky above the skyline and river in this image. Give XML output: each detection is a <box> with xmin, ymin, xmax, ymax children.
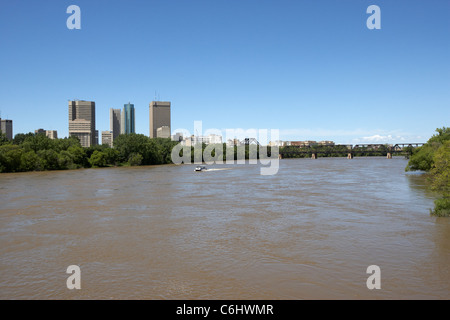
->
<box><xmin>0</xmin><ymin>0</ymin><xmax>450</xmax><ymax>143</ymax></box>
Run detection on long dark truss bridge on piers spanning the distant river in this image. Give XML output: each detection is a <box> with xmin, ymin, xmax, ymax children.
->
<box><xmin>279</xmin><ymin>143</ymin><xmax>424</xmax><ymax>159</ymax></box>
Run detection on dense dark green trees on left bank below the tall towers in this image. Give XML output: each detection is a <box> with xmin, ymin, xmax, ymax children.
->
<box><xmin>0</xmin><ymin>132</ymin><xmax>177</xmax><ymax>172</ymax></box>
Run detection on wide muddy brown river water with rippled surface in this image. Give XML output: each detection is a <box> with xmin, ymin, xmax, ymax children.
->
<box><xmin>0</xmin><ymin>158</ymin><xmax>450</xmax><ymax>299</ymax></box>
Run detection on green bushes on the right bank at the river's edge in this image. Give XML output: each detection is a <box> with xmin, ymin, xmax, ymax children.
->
<box><xmin>405</xmin><ymin>127</ymin><xmax>450</xmax><ymax>217</ymax></box>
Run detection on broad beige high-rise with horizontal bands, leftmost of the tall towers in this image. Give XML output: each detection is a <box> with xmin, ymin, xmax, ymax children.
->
<box><xmin>69</xmin><ymin>100</ymin><xmax>98</xmax><ymax>147</ymax></box>
